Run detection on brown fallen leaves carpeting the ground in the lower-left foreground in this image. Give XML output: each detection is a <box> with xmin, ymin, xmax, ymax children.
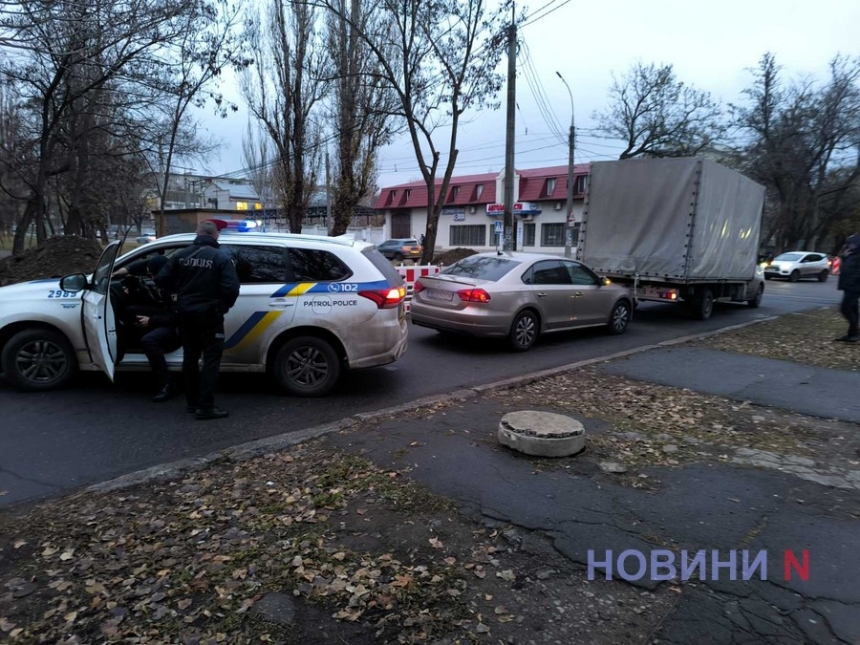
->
<box><xmin>0</xmin><ymin>445</ymin><xmax>524</xmax><ymax>645</ymax></box>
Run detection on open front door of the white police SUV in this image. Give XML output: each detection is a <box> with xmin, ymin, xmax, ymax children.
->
<box><xmin>82</xmin><ymin>240</ymin><xmax>122</xmax><ymax>381</ymax></box>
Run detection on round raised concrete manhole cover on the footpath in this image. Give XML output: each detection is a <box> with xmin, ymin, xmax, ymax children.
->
<box><xmin>498</xmin><ymin>410</ymin><xmax>585</xmax><ymax>457</ymax></box>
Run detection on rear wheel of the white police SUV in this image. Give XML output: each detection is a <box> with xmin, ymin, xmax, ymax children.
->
<box><xmin>275</xmin><ymin>336</ymin><xmax>340</xmax><ymax>396</ymax></box>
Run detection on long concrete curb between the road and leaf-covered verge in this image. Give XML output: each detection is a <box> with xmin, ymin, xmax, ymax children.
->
<box><xmin>84</xmin><ymin>316</ymin><xmax>779</xmax><ymax>493</ymax></box>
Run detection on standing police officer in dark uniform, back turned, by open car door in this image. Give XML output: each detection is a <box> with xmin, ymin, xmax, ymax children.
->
<box><xmin>156</xmin><ymin>221</ymin><xmax>239</xmax><ymax>419</ymax></box>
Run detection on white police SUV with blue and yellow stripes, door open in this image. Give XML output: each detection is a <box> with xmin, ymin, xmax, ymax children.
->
<box><xmin>0</xmin><ymin>232</ymin><xmax>407</xmax><ymax>396</ymax></box>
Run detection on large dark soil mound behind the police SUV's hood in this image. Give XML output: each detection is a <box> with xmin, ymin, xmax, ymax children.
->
<box><xmin>0</xmin><ymin>235</ymin><xmax>103</xmax><ymax>287</ymax></box>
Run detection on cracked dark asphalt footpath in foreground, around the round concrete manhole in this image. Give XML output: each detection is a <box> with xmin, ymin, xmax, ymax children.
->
<box><xmin>326</xmin><ymin>400</ymin><xmax>860</xmax><ymax>644</ymax></box>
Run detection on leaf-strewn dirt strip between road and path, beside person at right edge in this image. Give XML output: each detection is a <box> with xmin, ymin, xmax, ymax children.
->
<box><xmin>692</xmin><ymin>307</ymin><xmax>860</xmax><ymax>372</ymax></box>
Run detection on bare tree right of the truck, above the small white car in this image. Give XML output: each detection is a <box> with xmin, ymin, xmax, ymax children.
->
<box><xmin>732</xmin><ymin>54</ymin><xmax>860</xmax><ymax>250</ymax></box>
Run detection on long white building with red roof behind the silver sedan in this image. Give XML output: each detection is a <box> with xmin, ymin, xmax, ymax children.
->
<box><xmin>374</xmin><ymin>164</ymin><xmax>589</xmax><ymax>254</ymax></box>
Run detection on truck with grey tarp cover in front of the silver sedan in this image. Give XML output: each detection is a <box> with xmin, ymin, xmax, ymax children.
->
<box><xmin>576</xmin><ymin>157</ymin><xmax>765</xmax><ymax>320</ymax></box>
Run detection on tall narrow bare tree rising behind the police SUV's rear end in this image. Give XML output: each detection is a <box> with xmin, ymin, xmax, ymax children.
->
<box><xmin>327</xmin><ymin>0</ymin><xmax>397</xmax><ymax>235</ymax></box>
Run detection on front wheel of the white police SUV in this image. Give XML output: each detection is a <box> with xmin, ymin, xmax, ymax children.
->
<box><xmin>0</xmin><ymin>329</ymin><xmax>78</xmax><ymax>391</ymax></box>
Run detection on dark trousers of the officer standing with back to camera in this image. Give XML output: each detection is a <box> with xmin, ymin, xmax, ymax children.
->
<box><xmin>179</xmin><ymin>314</ymin><xmax>224</xmax><ymax>410</ymax></box>
